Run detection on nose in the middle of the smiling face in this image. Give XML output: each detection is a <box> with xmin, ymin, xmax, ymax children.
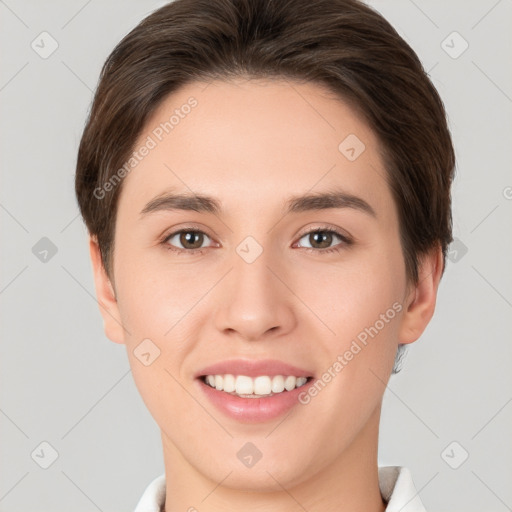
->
<box><xmin>215</xmin><ymin>246</ymin><xmax>296</xmax><ymax>341</ymax></box>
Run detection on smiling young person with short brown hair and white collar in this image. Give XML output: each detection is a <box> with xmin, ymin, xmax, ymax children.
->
<box><xmin>76</xmin><ymin>0</ymin><xmax>455</xmax><ymax>512</ymax></box>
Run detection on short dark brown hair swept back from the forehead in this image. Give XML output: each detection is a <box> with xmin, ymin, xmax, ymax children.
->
<box><xmin>76</xmin><ymin>0</ymin><xmax>455</xmax><ymax>368</ymax></box>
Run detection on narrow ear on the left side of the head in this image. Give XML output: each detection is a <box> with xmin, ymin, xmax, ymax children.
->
<box><xmin>89</xmin><ymin>236</ymin><xmax>125</xmax><ymax>343</ymax></box>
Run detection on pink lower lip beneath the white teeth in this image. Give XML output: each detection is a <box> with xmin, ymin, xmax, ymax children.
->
<box><xmin>197</xmin><ymin>378</ymin><xmax>314</xmax><ymax>423</ymax></box>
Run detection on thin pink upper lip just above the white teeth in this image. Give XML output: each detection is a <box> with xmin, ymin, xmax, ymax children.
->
<box><xmin>195</xmin><ymin>359</ymin><xmax>313</xmax><ymax>378</ymax></box>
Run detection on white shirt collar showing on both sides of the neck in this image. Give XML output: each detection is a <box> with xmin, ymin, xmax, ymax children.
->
<box><xmin>134</xmin><ymin>466</ymin><xmax>426</xmax><ymax>512</ymax></box>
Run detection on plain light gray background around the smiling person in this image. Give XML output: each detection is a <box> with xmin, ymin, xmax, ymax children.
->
<box><xmin>0</xmin><ymin>0</ymin><xmax>512</xmax><ymax>512</ymax></box>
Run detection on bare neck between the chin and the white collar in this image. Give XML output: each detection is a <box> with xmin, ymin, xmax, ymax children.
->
<box><xmin>162</xmin><ymin>405</ymin><xmax>386</xmax><ymax>512</ymax></box>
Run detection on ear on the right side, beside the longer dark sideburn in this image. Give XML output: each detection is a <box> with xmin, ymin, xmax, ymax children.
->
<box><xmin>398</xmin><ymin>246</ymin><xmax>443</xmax><ymax>344</ymax></box>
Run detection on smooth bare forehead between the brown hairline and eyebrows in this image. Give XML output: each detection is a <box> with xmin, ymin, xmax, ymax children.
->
<box><xmin>119</xmin><ymin>79</ymin><xmax>390</xmax><ymax>219</ymax></box>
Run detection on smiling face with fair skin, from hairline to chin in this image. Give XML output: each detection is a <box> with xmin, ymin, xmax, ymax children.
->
<box><xmin>89</xmin><ymin>80</ymin><xmax>440</xmax><ymax>490</ymax></box>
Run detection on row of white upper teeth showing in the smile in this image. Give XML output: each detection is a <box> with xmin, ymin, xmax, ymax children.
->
<box><xmin>205</xmin><ymin>374</ymin><xmax>308</xmax><ymax>398</ymax></box>
